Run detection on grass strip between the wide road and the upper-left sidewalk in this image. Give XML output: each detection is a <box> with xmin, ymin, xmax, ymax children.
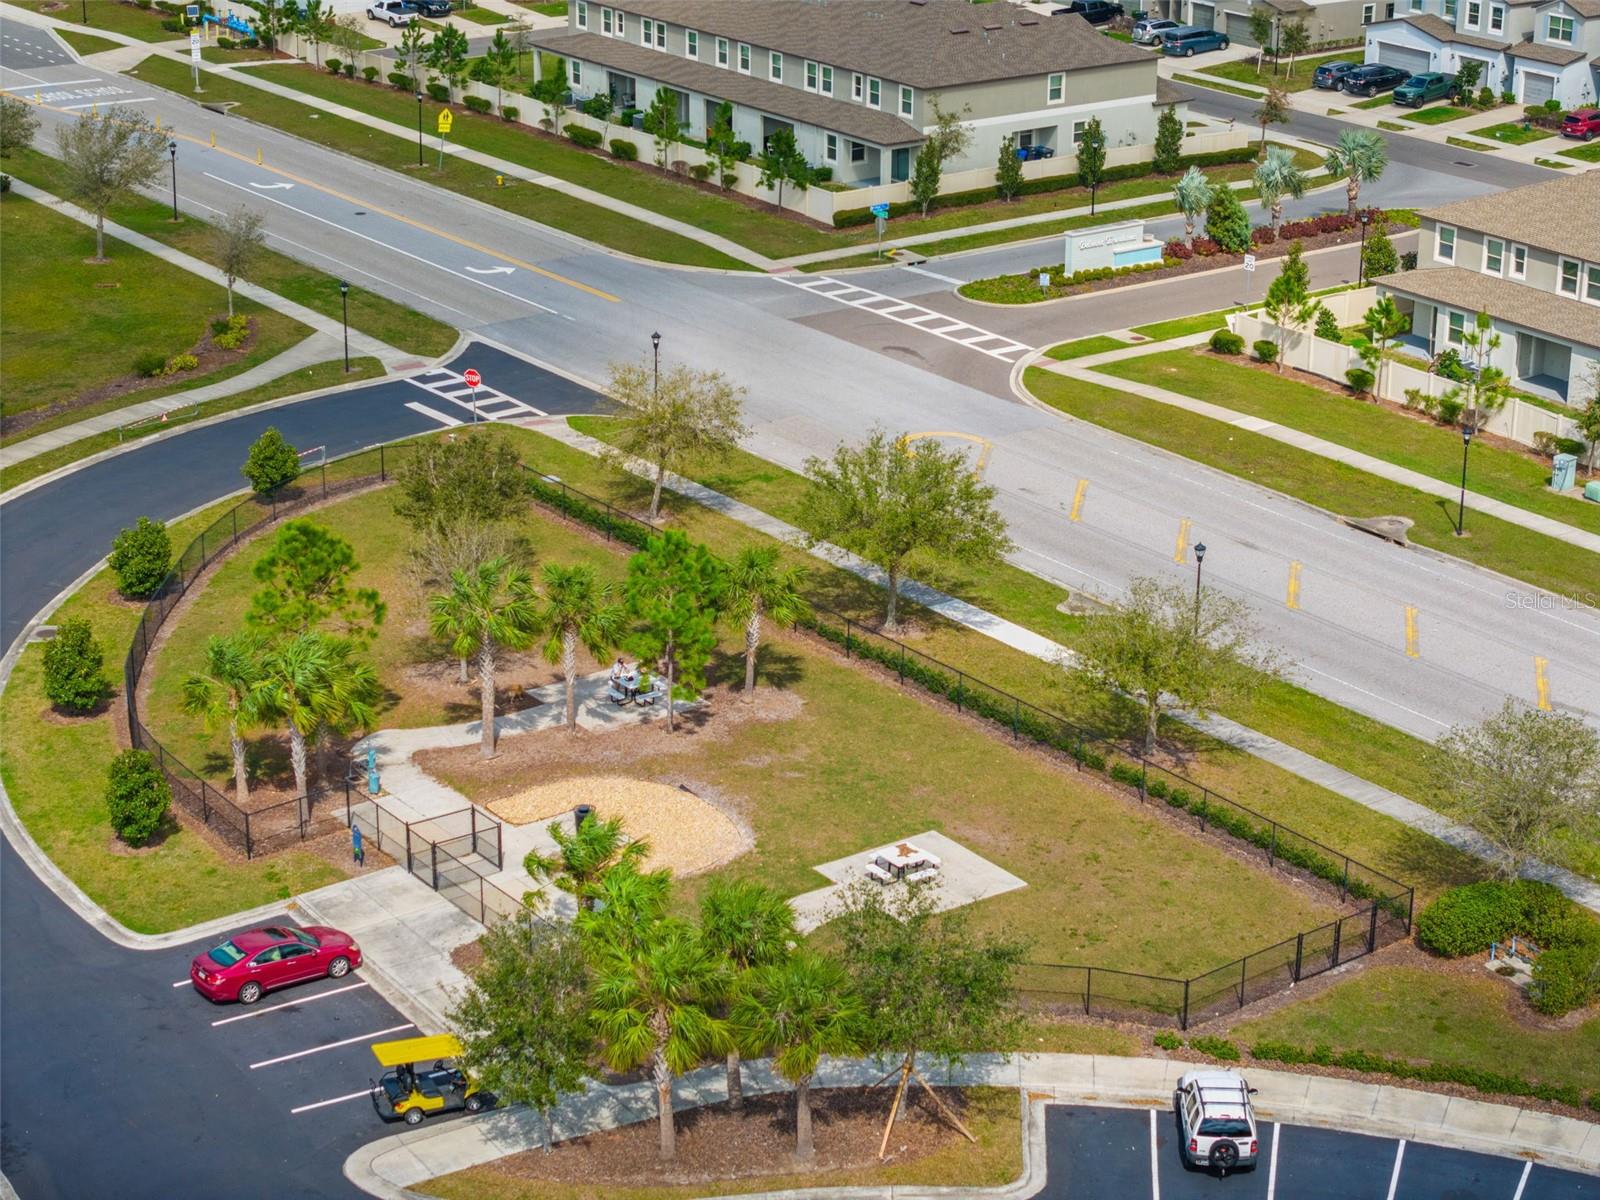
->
<box><xmin>10</xmin><ymin>150</ymin><xmax>456</xmax><ymax>358</ymax></box>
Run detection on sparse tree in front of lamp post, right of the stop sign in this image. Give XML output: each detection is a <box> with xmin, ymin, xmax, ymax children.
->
<box><xmin>606</xmin><ymin>363</ymin><xmax>750</xmax><ymax>522</ymax></box>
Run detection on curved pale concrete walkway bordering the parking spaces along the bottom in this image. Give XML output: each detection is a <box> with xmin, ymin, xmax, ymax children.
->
<box><xmin>344</xmin><ymin>1054</ymin><xmax>1600</xmax><ymax>1200</ymax></box>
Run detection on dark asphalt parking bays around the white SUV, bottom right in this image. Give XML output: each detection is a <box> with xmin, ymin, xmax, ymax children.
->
<box><xmin>1038</xmin><ymin>1104</ymin><xmax>1600</xmax><ymax>1200</ymax></box>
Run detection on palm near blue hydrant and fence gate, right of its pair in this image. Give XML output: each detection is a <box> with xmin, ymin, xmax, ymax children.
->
<box><xmin>250</xmin><ymin>630</ymin><xmax>378</xmax><ymax>819</ymax></box>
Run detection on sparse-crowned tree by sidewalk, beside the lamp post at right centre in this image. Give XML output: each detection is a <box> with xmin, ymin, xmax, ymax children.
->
<box><xmin>1070</xmin><ymin>579</ymin><xmax>1277</xmax><ymax>754</ymax></box>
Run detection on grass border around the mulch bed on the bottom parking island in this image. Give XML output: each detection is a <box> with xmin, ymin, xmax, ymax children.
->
<box><xmin>413</xmin><ymin>1088</ymin><xmax>1022</xmax><ymax>1200</ymax></box>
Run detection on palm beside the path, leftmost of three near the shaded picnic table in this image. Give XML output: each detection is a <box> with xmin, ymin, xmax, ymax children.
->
<box><xmin>427</xmin><ymin>557</ymin><xmax>539</xmax><ymax>758</ymax></box>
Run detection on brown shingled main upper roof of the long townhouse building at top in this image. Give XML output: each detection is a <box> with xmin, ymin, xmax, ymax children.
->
<box><xmin>590</xmin><ymin>0</ymin><xmax>1152</xmax><ymax>90</ymax></box>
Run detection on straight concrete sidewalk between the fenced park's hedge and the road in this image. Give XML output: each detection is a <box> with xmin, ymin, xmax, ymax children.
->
<box><xmin>518</xmin><ymin>419</ymin><xmax>1600</xmax><ymax>912</ymax></box>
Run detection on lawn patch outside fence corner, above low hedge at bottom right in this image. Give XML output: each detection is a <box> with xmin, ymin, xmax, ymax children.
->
<box><xmin>1230</xmin><ymin>966</ymin><xmax>1600</xmax><ymax>1093</ymax></box>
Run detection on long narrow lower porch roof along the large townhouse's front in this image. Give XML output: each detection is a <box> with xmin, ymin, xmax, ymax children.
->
<box><xmin>533</xmin><ymin>30</ymin><xmax>923</xmax><ymax>146</ymax></box>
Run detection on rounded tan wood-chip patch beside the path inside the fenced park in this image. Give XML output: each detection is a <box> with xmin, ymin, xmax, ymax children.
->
<box><xmin>488</xmin><ymin>774</ymin><xmax>750</xmax><ymax>875</ymax></box>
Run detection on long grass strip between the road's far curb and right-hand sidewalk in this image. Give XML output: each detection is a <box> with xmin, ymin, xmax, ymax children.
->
<box><xmin>1027</xmin><ymin>368</ymin><xmax>1595</xmax><ymax>611</ymax></box>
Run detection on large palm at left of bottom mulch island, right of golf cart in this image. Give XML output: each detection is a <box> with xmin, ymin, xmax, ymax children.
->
<box><xmin>589</xmin><ymin>918</ymin><xmax>731</xmax><ymax>1160</ymax></box>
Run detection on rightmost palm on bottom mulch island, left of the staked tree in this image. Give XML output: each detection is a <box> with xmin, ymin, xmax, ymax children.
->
<box><xmin>733</xmin><ymin>950</ymin><xmax>862</xmax><ymax>1162</ymax></box>
